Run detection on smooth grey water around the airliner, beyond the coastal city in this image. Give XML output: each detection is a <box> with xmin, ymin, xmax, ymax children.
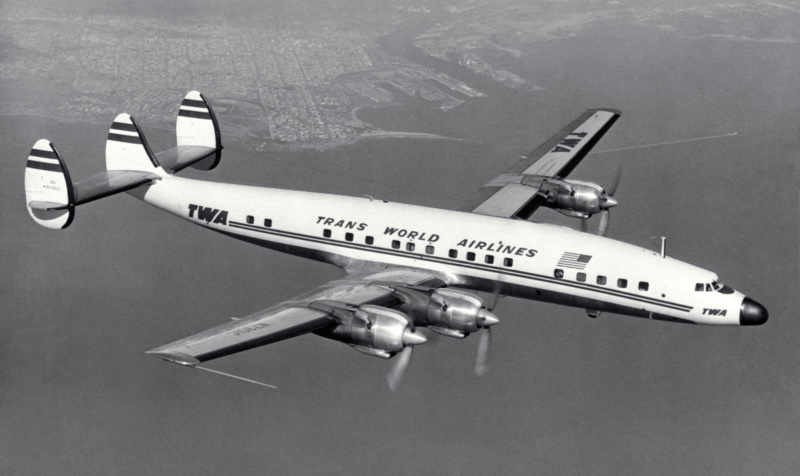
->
<box><xmin>0</xmin><ymin>1</ymin><xmax>800</xmax><ymax>475</ymax></box>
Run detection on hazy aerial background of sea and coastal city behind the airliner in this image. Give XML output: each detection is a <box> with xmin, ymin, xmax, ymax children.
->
<box><xmin>0</xmin><ymin>0</ymin><xmax>800</xmax><ymax>475</ymax></box>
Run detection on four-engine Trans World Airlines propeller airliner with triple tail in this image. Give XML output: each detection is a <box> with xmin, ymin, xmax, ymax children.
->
<box><xmin>25</xmin><ymin>91</ymin><xmax>769</xmax><ymax>390</ymax></box>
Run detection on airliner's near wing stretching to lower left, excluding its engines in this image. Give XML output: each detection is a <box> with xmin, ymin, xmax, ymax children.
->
<box><xmin>147</xmin><ymin>268</ymin><xmax>445</xmax><ymax>366</ymax></box>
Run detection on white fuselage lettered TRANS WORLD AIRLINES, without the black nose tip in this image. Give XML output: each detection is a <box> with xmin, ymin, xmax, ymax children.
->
<box><xmin>136</xmin><ymin>176</ymin><xmax>744</xmax><ymax>325</ymax></box>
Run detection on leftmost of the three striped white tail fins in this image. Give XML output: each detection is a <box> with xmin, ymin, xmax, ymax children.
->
<box><xmin>25</xmin><ymin>139</ymin><xmax>75</xmax><ymax>230</ymax></box>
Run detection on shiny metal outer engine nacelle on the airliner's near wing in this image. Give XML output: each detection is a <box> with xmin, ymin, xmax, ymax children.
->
<box><xmin>320</xmin><ymin>305</ymin><xmax>426</xmax><ymax>358</ymax></box>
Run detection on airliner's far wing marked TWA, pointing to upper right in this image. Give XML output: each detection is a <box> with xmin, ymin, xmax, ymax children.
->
<box><xmin>462</xmin><ymin>109</ymin><xmax>620</xmax><ymax>219</ymax></box>
